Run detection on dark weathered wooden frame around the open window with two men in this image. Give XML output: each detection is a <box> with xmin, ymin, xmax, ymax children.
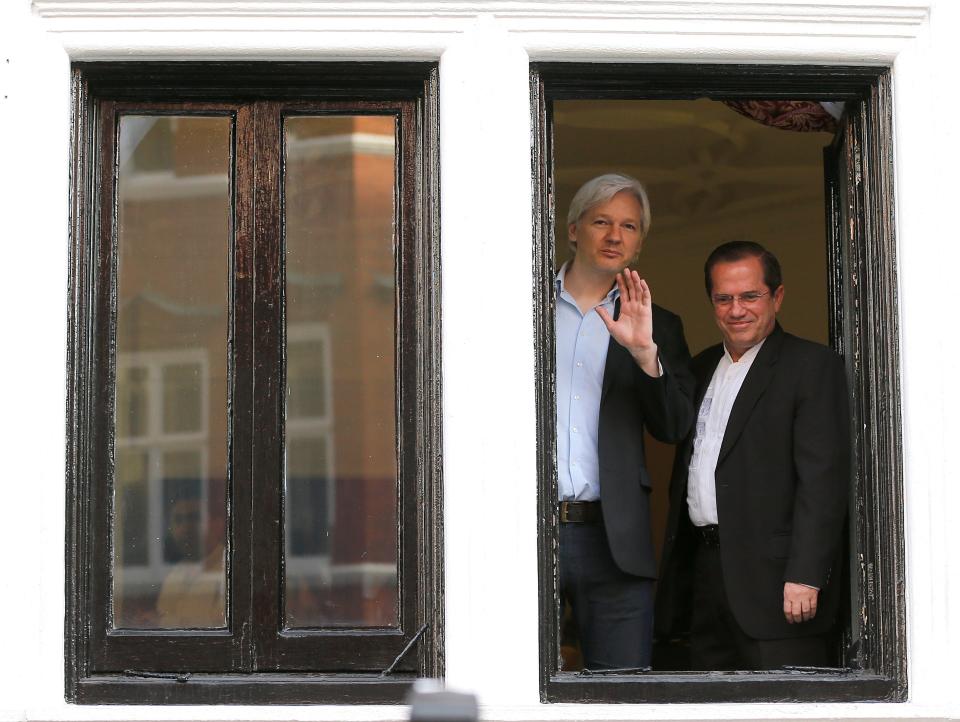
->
<box><xmin>531</xmin><ymin>63</ymin><xmax>907</xmax><ymax>703</ymax></box>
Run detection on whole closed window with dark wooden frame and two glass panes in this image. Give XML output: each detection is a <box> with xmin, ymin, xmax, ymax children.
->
<box><xmin>66</xmin><ymin>63</ymin><xmax>443</xmax><ymax>704</ymax></box>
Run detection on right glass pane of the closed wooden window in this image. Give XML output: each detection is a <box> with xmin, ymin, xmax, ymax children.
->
<box><xmin>284</xmin><ymin>116</ymin><xmax>399</xmax><ymax>627</ymax></box>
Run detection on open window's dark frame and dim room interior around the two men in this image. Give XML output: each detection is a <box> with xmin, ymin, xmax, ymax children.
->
<box><xmin>531</xmin><ymin>63</ymin><xmax>906</xmax><ymax>702</ymax></box>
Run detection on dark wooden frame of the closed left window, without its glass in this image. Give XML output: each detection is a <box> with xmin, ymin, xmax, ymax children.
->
<box><xmin>65</xmin><ymin>62</ymin><xmax>443</xmax><ymax>704</ymax></box>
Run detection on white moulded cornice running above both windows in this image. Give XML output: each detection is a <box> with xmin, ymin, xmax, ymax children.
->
<box><xmin>33</xmin><ymin>0</ymin><xmax>929</xmax><ymax>63</ymax></box>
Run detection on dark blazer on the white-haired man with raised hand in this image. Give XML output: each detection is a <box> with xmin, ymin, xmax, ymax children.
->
<box><xmin>597</xmin><ymin>301</ymin><xmax>693</xmax><ymax>579</ymax></box>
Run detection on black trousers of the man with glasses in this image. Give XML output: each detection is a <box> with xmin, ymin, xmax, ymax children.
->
<box><xmin>690</xmin><ymin>541</ymin><xmax>828</xmax><ymax>670</ymax></box>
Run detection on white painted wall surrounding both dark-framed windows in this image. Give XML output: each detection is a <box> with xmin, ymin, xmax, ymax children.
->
<box><xmin>0</xmin><ymin>0</ymin><xmax>960</xmax><ymax>722</ymax></box>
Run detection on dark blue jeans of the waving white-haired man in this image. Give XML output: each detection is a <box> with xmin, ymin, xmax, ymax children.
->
<box><xmin>559</xmin><ymin>521</ymin><xmax>653</xmax><ymax>669</ymax></box>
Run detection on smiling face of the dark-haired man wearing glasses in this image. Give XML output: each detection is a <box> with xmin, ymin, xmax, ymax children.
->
<box><xmin>710</xmin><ymin>258</ymin><xmax>783</xmax><ymax>361</ymax></box>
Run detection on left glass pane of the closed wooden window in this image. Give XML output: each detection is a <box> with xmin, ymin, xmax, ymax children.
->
<box><xmin>113</xmin><ymin>115</ymin><xmax>232</xmax><ymax>629</ymax></box>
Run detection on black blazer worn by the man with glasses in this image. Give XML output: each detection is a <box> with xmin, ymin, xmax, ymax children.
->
<box><xmin>656</xmin><ymin>324</ymin><xmax>851</xmax><ymax>639</ymax></box>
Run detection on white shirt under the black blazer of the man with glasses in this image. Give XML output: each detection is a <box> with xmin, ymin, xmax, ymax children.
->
<box><xmin>687</xmin><ymin>339</ymin><xmax>766</xmax><ymax>526</ymax></box>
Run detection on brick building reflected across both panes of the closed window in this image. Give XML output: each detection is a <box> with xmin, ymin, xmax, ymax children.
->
<box><xmin>115</xmin><ymin>116</ymin><xmax>398</xmax><ymax>627</ymax></box>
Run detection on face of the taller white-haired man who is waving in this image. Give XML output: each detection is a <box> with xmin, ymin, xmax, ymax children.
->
<box><xmin>568</xmin><ymin>191</ymin><xmax>643</xmax><ymax>275</ymax></box>
